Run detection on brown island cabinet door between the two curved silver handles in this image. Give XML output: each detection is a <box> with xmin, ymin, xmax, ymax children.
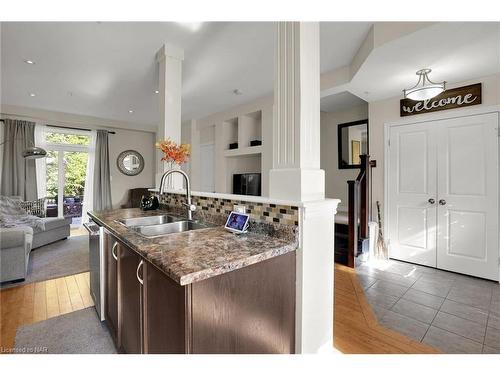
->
<box><xmin>118</xmin><ymin>244</ymin><xmax>142</xmax><ymax>354</ymax></box>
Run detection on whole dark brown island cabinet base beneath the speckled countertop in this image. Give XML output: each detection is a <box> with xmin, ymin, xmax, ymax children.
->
<box><xmin>105</xmin><ymin>233</ymin><xmax>295</xmax><ymax>354</ymax></box>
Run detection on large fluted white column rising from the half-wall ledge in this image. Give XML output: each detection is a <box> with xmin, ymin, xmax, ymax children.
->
<box><xmin>269</xmin><ymin>22</ymin><xmax>325</xmax><ymax>201</ymax></box>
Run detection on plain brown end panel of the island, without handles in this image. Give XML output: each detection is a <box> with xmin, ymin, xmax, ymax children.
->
<box><xmin>190</xmin><ymin>253</ymin><xmax>295</xmax><ymax>354</ymax></box>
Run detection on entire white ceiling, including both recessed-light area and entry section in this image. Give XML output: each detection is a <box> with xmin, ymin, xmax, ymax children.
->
<box><xmin>0</xmin><ymin>22</ymin><xmax>500</xmax><ymax>130</ymax></box>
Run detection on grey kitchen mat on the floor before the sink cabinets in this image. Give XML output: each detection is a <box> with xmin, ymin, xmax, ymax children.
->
<box><xmin>14</xmin><ymin>307</ymin><xmax>116</xmax><ymax>354</ymax></box>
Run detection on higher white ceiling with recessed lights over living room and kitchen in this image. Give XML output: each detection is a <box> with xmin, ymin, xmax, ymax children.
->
<box><xmin>1</xmin><ymin>22</ymin><xmax>371</xmax><ymax>129</ymax></box>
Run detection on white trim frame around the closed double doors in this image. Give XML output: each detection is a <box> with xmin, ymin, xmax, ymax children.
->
<box><xmin>382</xmin><ymin>105</ymin><xmax>500</xmax><ymax>284</ymax></box>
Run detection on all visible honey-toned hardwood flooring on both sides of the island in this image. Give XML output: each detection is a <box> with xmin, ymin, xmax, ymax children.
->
<box><xmin>0</xmin><ymin>265</ymin><xmax>439</xmax><ymax>354</ymax></box>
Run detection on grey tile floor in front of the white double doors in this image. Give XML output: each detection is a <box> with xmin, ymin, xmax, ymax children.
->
<box><xmin>356</xmin><ymin>260</ymin><xmax>500</xmax><ymax>354</ymax></box>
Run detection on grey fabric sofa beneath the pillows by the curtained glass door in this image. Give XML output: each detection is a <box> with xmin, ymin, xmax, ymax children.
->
<box><xmin>0</xmin><ymin>200</ymin><xmax>71</xmax><ymax>282</ymax></box>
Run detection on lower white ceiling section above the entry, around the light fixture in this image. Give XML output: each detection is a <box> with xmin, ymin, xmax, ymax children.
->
<box><xmin>349</xmin><ymin>22</ymin><xmax>500</xmax><ymax>101</ymax></box>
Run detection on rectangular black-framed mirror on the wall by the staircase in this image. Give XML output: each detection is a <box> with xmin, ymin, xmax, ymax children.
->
<box><xmin>337</xmin><ymin>120</ymin><xmax>368</xmax><ymax>169</ymax></box>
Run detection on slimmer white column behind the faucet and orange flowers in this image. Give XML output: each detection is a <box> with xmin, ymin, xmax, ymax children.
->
<box><xmin>156</xmin><ymin>44</ymin><xmax>184</xmax><ymax>189</ymax></box>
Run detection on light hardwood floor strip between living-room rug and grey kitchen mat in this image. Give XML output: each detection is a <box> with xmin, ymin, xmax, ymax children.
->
<box><xmin>0</xmin><ymin>272</ymin><xmax>94</xmax><ymax>352</ymax></box>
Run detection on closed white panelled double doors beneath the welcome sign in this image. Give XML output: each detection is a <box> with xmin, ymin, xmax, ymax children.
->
<box><xmin>387</xmin><ymin>113</ymin><xmax>499</xmax><ymax>280</ymax></box>
